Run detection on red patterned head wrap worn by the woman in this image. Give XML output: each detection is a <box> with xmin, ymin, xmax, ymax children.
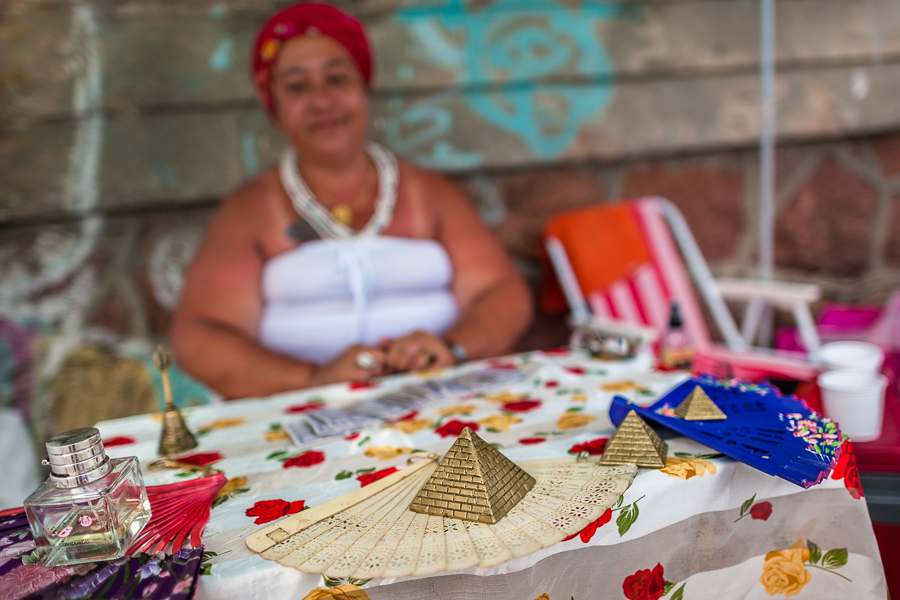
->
<box><xmin>250</xmin><ymin>2</ymin><xmax>374</xmax><ymax>117</ymax></box>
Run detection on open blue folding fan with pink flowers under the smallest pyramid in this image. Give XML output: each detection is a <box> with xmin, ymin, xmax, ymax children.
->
<box><xmin>609</xmin><ymin>376</ymin><xmax>841</xmax><ymax>488</ymax></box>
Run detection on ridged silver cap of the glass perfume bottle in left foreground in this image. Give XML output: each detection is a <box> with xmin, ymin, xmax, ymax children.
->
<box><xmin>46</xmin><ymin>427</ymin><xmax>111</xmax><ymax>487</ymax></box>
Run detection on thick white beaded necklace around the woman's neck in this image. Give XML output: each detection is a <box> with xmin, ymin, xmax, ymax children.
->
<box><xmin>278</xmin><ymin>142</ymin><xmax>397</xmax><ymax>239</ymax></box>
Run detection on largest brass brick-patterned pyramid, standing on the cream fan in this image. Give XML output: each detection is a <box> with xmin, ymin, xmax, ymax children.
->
<box><xmin>409</xmin><ymin>427</ymin><xmax>534</xmax><ymax>524</ymax></box>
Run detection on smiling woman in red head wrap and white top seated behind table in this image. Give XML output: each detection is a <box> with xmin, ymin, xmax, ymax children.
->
<box><xmin>171</xmin><ymin>4</ymin><xmax>531</xmax><ymax>398</ymax></box>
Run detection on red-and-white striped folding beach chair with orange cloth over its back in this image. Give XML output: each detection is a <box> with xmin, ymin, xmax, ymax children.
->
<box><xmin>544</xmin><ymin>197</ymin><xmax>819</xmax><ymax>381</ymax></box>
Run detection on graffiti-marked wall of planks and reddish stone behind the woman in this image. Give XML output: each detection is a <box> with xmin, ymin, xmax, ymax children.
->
<box><xmin>0</xmin><ymin>0</ymin><xmax>900</xmax><ymax>440</ymax></box>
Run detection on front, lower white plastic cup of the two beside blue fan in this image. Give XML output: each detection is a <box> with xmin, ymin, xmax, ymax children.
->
<box><xmin>818</xmin><ymin>370</ymin><xmax>887</xmax><ymax>442</ymax></box>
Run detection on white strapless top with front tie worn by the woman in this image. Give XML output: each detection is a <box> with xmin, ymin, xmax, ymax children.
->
<box><xmin>258</xmin><ymin>236</ymin><xmax>459</xmax><ymax>364</ymax></box>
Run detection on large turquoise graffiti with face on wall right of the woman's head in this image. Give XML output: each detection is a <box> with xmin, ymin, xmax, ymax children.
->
<box><xmin>394</xmin><ymin>0</ymin><xmax>635</xmax><ymax>162</ymax></box>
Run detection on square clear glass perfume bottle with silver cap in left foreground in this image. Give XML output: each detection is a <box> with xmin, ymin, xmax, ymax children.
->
<box><xmin>25</xmin><ymin>427</ymin><xmax>150</xmax><ymax>567</ymax></box>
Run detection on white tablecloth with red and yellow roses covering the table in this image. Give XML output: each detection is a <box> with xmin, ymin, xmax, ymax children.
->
<box><xmin>97</xmin><ymin>350</ymin><xmax>887</xmax><ymax>600</ymax></box>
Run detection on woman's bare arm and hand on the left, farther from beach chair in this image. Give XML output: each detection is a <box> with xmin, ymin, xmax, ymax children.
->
<box><xmin>171</xmin><ymin>184</ymin><xmax>381</xmax><ymax>398</ymax></box>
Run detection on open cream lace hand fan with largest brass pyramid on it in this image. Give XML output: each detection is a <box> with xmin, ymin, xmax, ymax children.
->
<box><xmin>246</xmin><ymin>428</ymin><xmax>637</xmax><ymax>579</ymax></box>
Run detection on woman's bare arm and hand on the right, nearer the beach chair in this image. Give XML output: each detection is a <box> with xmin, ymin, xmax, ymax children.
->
<box><xmin>386</xmin><ymin>165</ymin><xmax>532</xmax><ymax>371</ymax></box>
